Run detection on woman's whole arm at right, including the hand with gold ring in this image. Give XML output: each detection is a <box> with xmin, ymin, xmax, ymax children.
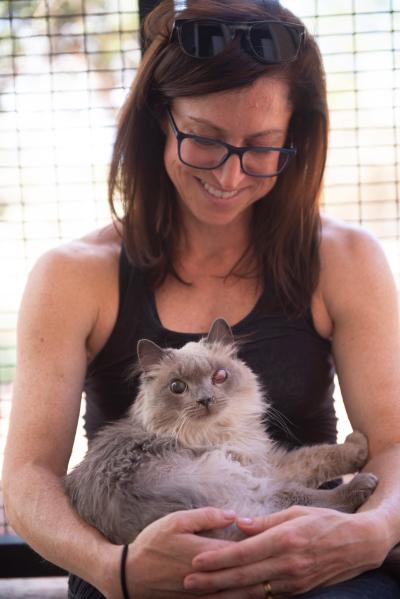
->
<box><xmin>181</xmin><ymin>223</ymin><xmax>400</xmax><ymax>599</ymax></box>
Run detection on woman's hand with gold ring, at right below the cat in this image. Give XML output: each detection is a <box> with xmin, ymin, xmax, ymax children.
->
<box><xmin>184</xmin><ymin>506</ymin><xmax>390</xmax><ymax>599</ymax></box>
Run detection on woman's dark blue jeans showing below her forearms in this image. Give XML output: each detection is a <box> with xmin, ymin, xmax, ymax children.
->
<box><xmin>68</xmin><ymin>569</ymin><xmax>400</xmax><ymax>599</ymax></box>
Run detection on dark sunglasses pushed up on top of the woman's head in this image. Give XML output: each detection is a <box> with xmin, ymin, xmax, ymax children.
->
<box><xmin>170</xmin><ymin>19</ymin><xmax>305</xmax><ymax>64</ymax></box>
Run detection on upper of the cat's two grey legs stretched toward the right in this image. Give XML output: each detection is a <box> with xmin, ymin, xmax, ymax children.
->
<box><xmin>272</xmin><ymin>431</ymin><xmax>368</xmax><ymax>487</ymax></box>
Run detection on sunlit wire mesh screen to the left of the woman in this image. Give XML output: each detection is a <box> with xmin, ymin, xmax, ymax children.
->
<box><xmin>0</xmin><ymin>0</ymin><xmax>140</xmax><ymax>531</ymax></box>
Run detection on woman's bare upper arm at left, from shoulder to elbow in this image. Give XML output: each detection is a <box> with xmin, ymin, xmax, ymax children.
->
<box><xmin>8</xmin><ymin>227</ymin><xmax>120</xmax><ymax>476</ymax></box>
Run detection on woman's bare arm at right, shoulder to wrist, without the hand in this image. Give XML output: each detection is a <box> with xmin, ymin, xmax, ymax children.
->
<box><xmin>325</xmin><ymin>220</ymin><xmax>400</xmax><ymax>580</ymax></box>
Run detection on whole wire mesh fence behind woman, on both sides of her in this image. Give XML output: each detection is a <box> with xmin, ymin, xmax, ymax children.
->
<box><xmin>0</xmin><ymin>0</ymin><xmax>400</xmax><ymax>531</ymax></box>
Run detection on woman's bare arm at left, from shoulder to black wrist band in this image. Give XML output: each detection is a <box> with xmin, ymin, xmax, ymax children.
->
<box><xmin>3</xmin><ymin>248</ymin><xmax>120</xmax><ymax>584</ymax></box>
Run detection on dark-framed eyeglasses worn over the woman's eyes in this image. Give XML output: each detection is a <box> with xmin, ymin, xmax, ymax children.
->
<box><xmin>167</xmin><ymin>107</ymin><xmax>296</xmax><ymax>178</ymax></box>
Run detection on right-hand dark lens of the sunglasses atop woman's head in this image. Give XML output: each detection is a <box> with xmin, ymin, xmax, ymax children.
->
<box><xmin>250</xmin><ymin>23</ymin><xmax>302</xmax><ymax>64</ymax></box>
